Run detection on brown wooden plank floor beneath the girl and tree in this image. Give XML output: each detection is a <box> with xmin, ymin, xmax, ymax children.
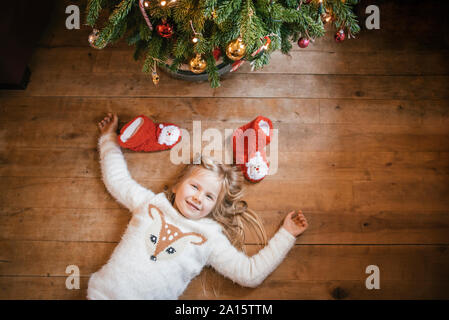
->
<box><xmin>0</xmin><ymin>0</ymin><xmax>449</xmax><ymax>299</ymax></box>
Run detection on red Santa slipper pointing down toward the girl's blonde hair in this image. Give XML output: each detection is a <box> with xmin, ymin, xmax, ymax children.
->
<box><xmin>232</xmin><ymin>116</ymin><xmax>273</xmax><ymax>182</ymax></box>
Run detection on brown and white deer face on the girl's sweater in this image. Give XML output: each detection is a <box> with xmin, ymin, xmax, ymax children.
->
<box><xmin>145</xmin><ymin>205</ymin><xmax>207</xmax><ymax>262</ymax></box>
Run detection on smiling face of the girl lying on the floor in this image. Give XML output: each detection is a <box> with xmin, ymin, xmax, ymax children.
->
<box><xmin>173</xmin><ymin>167</ymin><xmax>221</xmax><ymax>219</ymax></box>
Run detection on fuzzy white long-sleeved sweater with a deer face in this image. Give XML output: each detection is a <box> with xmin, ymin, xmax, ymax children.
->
<box><xmin>87</xmin><ymin>133</ymin><xmax>295</xmax><ymax>299</ymax></box>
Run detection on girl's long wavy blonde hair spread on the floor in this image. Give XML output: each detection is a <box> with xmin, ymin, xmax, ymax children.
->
<box><xmin>165</xmin><ymin>157</ymin><xmax>267</xmax><ymax>251</ymax></box>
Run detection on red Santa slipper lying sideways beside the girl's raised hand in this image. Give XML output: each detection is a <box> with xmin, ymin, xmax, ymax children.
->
<box><xmin>118</xmin><ymin>115</ymin><xmax>181</xmax><ymax>152</ymax></box>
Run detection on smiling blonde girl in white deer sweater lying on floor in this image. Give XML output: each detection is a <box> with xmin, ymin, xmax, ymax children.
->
<box><xmin>87</xmin><ymin>114</ymin><xmax>308</xmax><ymax>299</ymax></box>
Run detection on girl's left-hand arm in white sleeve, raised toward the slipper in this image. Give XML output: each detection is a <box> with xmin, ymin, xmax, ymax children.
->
<box><xmin>98</xmin><ymin>113</ymin><xmax>154</xmax><ymax>211</ymax></box>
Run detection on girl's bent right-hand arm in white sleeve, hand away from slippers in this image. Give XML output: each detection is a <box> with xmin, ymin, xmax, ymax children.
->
<box><xmin>208</xmin><ymin>212</ymin><xmax>308</xmax><ymax>287</ymax></box>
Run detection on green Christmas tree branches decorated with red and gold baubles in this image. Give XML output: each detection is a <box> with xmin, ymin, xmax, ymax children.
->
<box><xmin>86</xmin><ymin>0</ymin><xmax>360</xmax><ymax>88</ymax></box>
